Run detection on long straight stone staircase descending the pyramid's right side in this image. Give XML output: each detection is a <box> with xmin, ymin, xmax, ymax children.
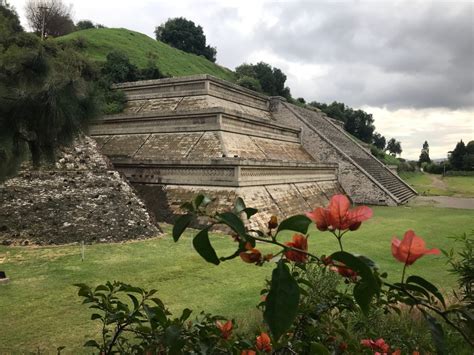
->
<box><xmin>285</xmin><ymin>104</ymin><xmax>417</xmax><ymax>204</ymax></box>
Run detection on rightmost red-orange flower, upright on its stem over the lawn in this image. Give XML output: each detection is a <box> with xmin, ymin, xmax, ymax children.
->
<box><xmin>392</xmin><ymin>229</ymin><xmax>439</xmax><ymax>265</ymax></box>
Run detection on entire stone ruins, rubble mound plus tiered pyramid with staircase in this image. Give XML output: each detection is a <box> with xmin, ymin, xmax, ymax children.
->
<box><xmin>0</xmin><ymin>75</ymin><xmax>416</xmax><ymax>244</ymax></box>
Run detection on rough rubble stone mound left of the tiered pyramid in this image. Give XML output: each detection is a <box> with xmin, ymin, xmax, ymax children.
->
<box><xmin>0</xmin><ymin>137</ymin><xmax>159</xmax><ymax>245</ymax></box>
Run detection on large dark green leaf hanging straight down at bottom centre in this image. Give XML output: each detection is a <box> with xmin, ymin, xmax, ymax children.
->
<box><xmin>263</xmin><ymin>260</ymin><xmax>300</xmax><ymax>341</ymax></box>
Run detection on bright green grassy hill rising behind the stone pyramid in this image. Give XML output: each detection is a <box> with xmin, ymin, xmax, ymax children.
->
<box><xmin>57</xmin><ymin>28</ymin><xmax>235</xmax><ymax>81</ymax></box>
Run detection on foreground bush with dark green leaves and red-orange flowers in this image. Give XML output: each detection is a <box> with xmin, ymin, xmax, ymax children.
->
<box><xmin>79</xmin><ymin>195</ymin><xmax>474</xmax><ymax>354</ymax></box>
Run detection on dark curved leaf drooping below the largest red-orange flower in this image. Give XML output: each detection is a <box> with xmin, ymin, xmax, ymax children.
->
<box><xmin>330</xmin><ymin>251</ymin><xmax>380</xmax><ymax>315</ymax></box>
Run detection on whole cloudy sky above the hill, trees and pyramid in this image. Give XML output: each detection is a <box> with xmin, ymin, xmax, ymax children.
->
<box><xmin>9</xmin><ymin>0</ymin><xmax>474</xmax><ymax>159</ymax></box>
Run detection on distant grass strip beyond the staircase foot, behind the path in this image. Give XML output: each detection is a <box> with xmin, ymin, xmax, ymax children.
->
<box><xmin>400</xmin><ymin>172</ymin><xmax>474</xmax><ymax>197</ymax></box>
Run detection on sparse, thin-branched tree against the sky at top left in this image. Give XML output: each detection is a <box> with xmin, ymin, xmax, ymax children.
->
<box><xmin>25</xmin><ymin>0</ymin><xmax>74</xmax><ymax>38</ymax></box>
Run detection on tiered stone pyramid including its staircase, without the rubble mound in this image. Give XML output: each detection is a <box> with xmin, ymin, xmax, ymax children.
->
<box><xmin>91</xmin><ymin>75</ymin><xmax>416</xmax><ymax>228</ymax></box>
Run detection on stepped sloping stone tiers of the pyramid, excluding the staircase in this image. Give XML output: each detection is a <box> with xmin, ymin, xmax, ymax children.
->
<box><xmin>91</xmin><ymin>75</ymin><xmax>342</xmax><ymax>226</ymax></box>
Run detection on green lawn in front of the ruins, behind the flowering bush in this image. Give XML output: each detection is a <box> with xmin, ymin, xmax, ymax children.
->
<box><xmin>0</xmin><ymin>207</ymin><xmax>474</xmax><ymax>353</ymax></box>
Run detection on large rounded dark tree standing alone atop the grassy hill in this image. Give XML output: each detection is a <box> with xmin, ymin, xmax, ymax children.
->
<box><xmin>155</xmin><ymin>17</ymin><xmax>217</xmax><ymax>62</ymax></box>
